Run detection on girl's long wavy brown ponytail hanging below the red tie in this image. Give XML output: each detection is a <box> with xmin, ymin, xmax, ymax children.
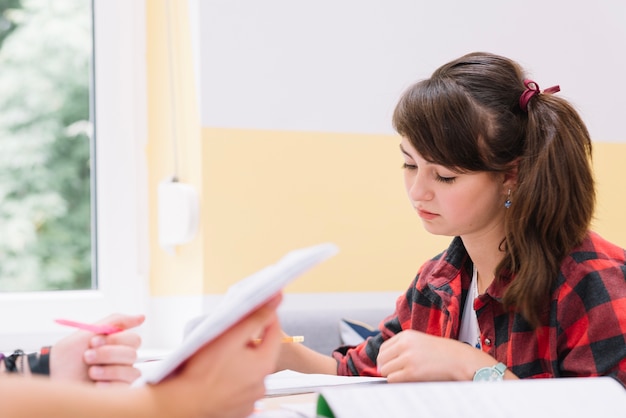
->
<box><xmin>497</xmin><ymin>90</ymin><xmax>595</xmax><ymax>326</ymax></box>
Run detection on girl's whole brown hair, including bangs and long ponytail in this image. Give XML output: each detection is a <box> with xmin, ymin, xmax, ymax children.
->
<box><xmin>393</xmin><ymin>52</ymin><xmax>595</xmax><ymax>326</ymax></box>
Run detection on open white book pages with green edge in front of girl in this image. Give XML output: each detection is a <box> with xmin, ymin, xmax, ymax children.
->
<box><xmin>318</xmin><ymin>377</ymin><xmax>626</xmax><ymax>418</ymax></box>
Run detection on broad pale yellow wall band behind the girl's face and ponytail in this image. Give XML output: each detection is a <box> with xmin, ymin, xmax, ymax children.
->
<box><xmin>193</xmin><ymin>128</ymin><xmax>626</xmax><ymax>292</ymax></box>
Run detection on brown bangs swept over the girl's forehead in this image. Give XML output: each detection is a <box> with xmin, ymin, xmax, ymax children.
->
<box><xmin>392</xmin><ymin>79</ymin><xmax>489</xmax><ymax>171</ymax></box>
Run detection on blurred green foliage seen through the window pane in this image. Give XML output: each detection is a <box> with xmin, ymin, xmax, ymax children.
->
<box><xmin>0</xmin><ymin>0</ymin><xmax>93</xmax><ymax>292</ymax></box>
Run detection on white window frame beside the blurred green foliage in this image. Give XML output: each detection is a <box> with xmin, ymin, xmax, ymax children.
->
<box><xmin>0</xmin><ymin>0</ymin><xmax>149</xmax><ymax>352</ymax></box>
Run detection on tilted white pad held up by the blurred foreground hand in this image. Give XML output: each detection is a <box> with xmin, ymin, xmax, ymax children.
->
<box><xmin>138</xmin><ymin>243</ymin><xmax>339</xmax><ymax>384</ymax></box>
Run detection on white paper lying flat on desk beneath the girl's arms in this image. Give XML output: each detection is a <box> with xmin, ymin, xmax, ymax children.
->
<box><xmin>265</xmin><ymin>370</ymin><xmax>387</xmax><ymax>396</ymax></box>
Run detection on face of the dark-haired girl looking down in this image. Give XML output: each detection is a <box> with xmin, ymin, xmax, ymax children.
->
<box><xmin>400</xmin><ymin>138</ymin><xmax>508</xmax><ymax>237</ymax></box>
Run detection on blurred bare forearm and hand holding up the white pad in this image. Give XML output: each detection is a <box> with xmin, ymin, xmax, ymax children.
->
<box><xmin>0</xmin><ymin>295</ymin><xmax>281</xmax><ymax>418</ymax></box>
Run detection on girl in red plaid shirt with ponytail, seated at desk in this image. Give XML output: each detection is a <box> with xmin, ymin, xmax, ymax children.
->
<box><xmin>279</xmin><ymin>53</ymin><xmax>626</xmax><ymax>385</ymax></box>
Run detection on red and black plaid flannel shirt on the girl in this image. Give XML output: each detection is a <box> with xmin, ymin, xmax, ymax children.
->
<box><xmin>333</xmin><ymin>232</ymin><xmax>626</xmax><ymax>386</ymax></box>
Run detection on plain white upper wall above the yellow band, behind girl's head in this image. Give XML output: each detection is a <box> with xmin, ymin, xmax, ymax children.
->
<box><xmin>194</xmin><ymin>0</ymin><xmax>626</xmax><ymax>142</ymax></box>
